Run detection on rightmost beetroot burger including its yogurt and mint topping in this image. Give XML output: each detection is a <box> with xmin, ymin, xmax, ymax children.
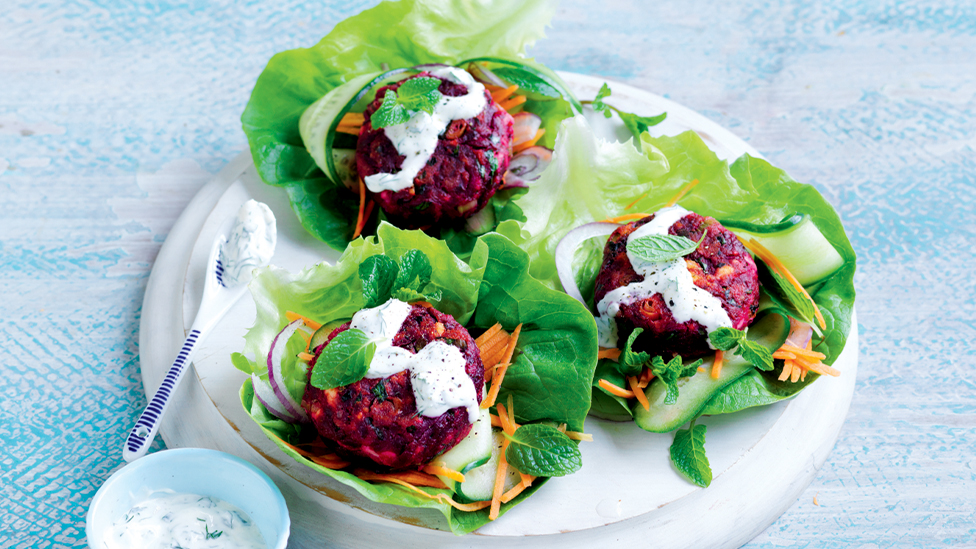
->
<box><xmin>594</xmin><ymin>206</ymin><xmax>759</xmax><ymax>359</ymax></box>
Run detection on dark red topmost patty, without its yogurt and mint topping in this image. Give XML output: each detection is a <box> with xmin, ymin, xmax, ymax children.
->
<box><xmin>356</xmin><ymin>72</ymin><xmax>514</xmax><ymax>228</ymax></box>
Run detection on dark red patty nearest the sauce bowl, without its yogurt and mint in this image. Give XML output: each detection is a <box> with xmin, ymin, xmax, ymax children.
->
<box><xmin>302</xmin><ymin>305</ymin><xmax>485</xmax><ymax>469</ymax></box>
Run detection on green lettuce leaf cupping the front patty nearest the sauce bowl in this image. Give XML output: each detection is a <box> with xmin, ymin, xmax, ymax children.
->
<box><xmin>232</xmin><ymin>224</ymin><xmax>597</xmax><ymax>534</ymax></box>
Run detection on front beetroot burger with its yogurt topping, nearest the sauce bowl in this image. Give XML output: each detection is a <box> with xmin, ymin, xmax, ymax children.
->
<box><xmin>302</xmin><ymin>299</ymin><xmax>485</xmax><ymax>470</ymax></box>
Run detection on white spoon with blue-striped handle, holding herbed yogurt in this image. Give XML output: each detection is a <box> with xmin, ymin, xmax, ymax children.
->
<box><xmin>122</xmin><ymin>200</ymin><xmax>277</xmax><ymax>462</ymax></box>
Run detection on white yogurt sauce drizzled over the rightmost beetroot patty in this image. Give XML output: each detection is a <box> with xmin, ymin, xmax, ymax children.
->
<box><xmin>596</xmin><ymin>206</ymin><xmax>732</xmax><ymax>349</ymax></box>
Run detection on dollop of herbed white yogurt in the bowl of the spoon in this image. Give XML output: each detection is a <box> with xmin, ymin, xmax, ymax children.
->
<box><xmin>220</xmin><ymin>200</ymin><xmax>278</xmax><ymax>287</ymax></box>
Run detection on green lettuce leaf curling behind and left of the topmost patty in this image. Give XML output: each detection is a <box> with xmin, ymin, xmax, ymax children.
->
<box><xmin>241</xmin><ymin>0</ymin><xmax>569</xmax><ymax>250</ymax></box>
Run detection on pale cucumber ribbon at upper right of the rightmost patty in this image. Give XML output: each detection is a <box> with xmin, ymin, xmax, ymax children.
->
<box><xmin>721</xmin><ymin>214</ymin><xmax>844</xmax><ymax>286</ymax></box>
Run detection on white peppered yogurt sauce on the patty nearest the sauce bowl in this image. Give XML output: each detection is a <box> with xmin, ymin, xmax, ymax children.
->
<box><xmin>349</xmin><ymin>299</ymin><xmax>480</xmax><ymax>423</ymax></box>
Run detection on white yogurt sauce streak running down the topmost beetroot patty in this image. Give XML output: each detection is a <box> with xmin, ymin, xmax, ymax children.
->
<box><xmin>363</xmin><ymin>67</ymin><xmax>488</xmax><ymax>193</ymax></box>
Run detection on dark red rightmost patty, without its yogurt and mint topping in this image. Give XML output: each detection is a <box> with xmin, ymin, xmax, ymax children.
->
<box><xmin>594</xmin><ymin>213</ymin><xmax>759</xmax><ymax>358</ymax></box>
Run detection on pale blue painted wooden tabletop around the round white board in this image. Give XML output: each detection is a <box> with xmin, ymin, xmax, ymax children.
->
<box><xmin>0</xmin><ymin>0</ymin><xmax>976</xmax><ymax>548</ymax></box>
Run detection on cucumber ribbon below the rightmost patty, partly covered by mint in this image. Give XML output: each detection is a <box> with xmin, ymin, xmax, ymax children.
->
<box><xmin>634</xmin><ymin>312</ymin><xmax>790</xmax><ymax>433</ymax></box>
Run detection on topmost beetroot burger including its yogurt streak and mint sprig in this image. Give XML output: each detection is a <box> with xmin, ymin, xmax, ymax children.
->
<box><xmin>356</xmin><ymin>66</ymin><xmax>514</xmax><ymax>228</ymax></box>
